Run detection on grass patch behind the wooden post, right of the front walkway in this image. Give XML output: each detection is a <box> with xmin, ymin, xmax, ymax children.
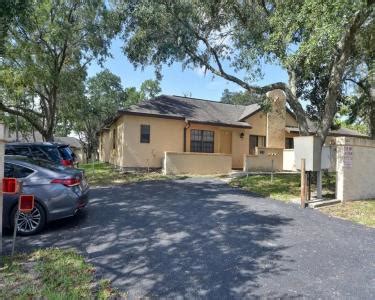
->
<box><xmin>231</xmin><ymin>174</ymin><xmax>335</xmax><ymax>201</ymax></box>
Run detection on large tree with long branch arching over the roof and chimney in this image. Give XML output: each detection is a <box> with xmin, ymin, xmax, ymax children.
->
<box><xmin>117</xmin><ymin>0</ymin><xmax>374</xmax><ymax>143</ymax></box>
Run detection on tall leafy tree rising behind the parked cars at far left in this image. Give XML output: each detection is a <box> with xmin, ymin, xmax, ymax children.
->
<box><xmin>0</xmin><ymin>0</ymin><xmax>112</xmax><ymax>140</ymax></box>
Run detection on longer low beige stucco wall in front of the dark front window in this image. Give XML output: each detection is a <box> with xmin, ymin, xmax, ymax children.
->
<box><xmin>163</xmin><ymin>152</ymin><xmax>232</xmax><ymax>175</ymax></box>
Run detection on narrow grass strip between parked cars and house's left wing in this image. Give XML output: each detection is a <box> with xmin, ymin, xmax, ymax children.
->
<box><xmin>79</xmin><ymin>162</ymin><xmax>178</xmax><ymax>186</ymax></box>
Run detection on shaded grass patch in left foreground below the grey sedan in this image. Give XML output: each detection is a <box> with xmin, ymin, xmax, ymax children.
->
<box><xmin>0</xmin><ymin>248</ymin><xmax>121</xmax><ymax>299</ymax></box>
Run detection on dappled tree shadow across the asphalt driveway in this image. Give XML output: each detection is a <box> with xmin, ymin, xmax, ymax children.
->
<box><xmin>2</xmin><ymin>179</ymin><xmax>295</xmax><ymax>298</ymax></box>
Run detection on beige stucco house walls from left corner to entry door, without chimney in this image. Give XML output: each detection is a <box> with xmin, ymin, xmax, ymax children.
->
<box><xmin>99</xmin><ymin>115</ymin><xmax>250</xmax><ymax>168</ymax></box>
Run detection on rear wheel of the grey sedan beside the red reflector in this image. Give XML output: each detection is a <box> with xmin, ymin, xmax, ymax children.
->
<box><xmin>10</xmin><ymin>202</ymin><xmax>46</xmax><ymax>236</ymax></box>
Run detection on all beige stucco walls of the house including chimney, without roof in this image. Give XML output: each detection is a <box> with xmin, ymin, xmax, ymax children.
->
<box><xmin>99</xmin><ymin>93</ymin><xmax>297</xmax><ymax>169</ymax></box>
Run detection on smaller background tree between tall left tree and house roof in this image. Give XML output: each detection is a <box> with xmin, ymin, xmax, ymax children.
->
<box><xmin>67</xmin><ymin>69</ymin><xmax>161</xmax><ymax>158</ymax></box>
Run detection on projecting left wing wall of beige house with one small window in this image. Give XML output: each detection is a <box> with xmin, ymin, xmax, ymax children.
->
<box><xmin>100</xmin><ymin>115</ymin><xmax>185</xmax><ymax>168</ymax></box>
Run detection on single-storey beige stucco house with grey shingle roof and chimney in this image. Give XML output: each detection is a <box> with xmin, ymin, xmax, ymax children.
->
<box><xmin>99</xmin><ymin>90</ymin><xmax>368</xmax><ymax>169</ymax></box>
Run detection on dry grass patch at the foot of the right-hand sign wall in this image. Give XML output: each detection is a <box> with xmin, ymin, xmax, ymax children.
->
<box><xmin>319</xmin><ymin>199</ymin><xmax>375</xmax><ymax>228</ymax></box>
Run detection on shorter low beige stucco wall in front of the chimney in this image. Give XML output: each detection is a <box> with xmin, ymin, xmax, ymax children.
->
<box><xmin>243</xmin><ymin>147</ymin><xmax>283</xmax><ymax>172</ymax></box>
